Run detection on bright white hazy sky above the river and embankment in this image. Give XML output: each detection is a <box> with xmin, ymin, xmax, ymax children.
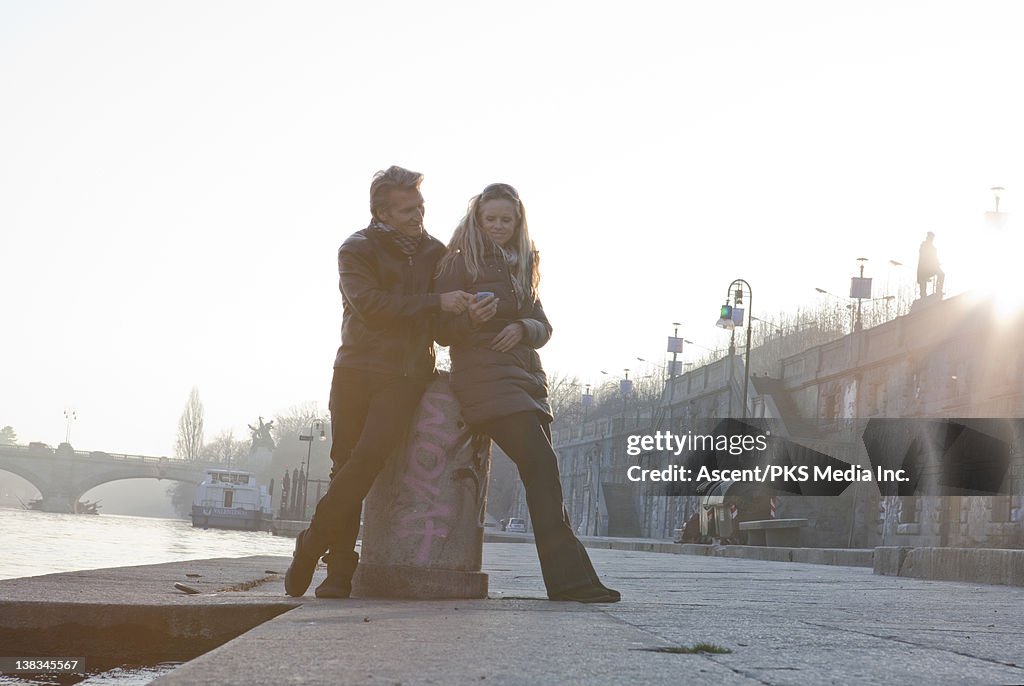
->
<box><xmin>0</xmin><ymin>0</ymin><xmax>1024</xmax><ymax>455</ymax></box>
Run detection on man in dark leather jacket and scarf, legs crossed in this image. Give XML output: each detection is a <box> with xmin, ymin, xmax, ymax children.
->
<box><xmin>285</xmin><ymin>167</ymin><xmax>473</xmax><ymax>598</ymax></box>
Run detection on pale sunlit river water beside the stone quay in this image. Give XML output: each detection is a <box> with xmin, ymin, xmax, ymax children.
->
<box><xmin>0</xmin><ymin>509</ymin><xmax>295</xmax><ymax>686</ymax></box>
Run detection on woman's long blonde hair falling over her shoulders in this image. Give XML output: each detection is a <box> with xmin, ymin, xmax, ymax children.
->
<box><xmin>437</xmin><ymin>183</ymin><xmax>541</xmax><ymax>303</ymax></box>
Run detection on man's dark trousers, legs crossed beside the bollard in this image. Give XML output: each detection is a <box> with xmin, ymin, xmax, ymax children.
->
<box><xmin>302</xmin><ymin>367</ymin><xmax>427</xmax><ymax>573</ymax></box>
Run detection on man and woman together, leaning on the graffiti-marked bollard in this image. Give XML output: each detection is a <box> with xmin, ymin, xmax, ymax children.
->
<box><xmin>285</xmin><ymin>167</ymin><xmax>620</xmax><ymax>603</ymax></box>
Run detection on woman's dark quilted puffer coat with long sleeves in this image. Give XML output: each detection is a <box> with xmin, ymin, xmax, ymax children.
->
<box><xmin>433</xmin><ymin>249</ymin><xmax>552</xmax><ymax>426</ymax></box>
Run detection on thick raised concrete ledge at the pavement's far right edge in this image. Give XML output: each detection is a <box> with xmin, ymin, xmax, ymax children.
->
<box><xmin>874</xmin><ymin>548</ymin><xmax>1024</xmax><ymax>586</ymax></box>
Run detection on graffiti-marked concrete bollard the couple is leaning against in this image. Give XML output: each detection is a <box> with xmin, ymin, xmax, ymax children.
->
<box><xmin>352</xmin><ymin>374</ymin><xmax>490</xmax><ymax>599</ymax></box>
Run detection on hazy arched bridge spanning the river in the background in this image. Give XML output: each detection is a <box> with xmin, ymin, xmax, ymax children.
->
<box><xmin>0</xmin><ymin>443</ymin><xmax>223</xmax><ymax>512</ymax></box>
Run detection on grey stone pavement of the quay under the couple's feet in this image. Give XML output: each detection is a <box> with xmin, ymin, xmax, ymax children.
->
<box><xmin>0</xmin><ymin>543</ymin><xmax>1024</xmax><ymax>686</ymax></box>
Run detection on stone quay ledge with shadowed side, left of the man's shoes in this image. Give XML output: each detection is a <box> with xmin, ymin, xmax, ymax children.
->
<box><xmin>0</xmin><ymin>557</ymin><xmax>300</xmax><ymax>663</ymax></box>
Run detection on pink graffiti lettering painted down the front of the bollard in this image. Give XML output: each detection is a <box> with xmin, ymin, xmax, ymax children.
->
<box><xmin>397</xmin><ymin>392</ymin><xmax>459</xmax><ymax>565</ymax></box>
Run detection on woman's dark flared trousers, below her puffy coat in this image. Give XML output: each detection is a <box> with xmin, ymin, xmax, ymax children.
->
<box><xmin>474</xmin><ymin>412</ymin><xmax>601</xmax><ymax>596</ymax></box>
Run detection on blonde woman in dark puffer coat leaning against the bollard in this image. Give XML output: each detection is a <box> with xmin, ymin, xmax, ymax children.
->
<box><xmin>434</xmin><ymin>183</ymin><xmax>620</xmax><ymax>603</ymax></box>
